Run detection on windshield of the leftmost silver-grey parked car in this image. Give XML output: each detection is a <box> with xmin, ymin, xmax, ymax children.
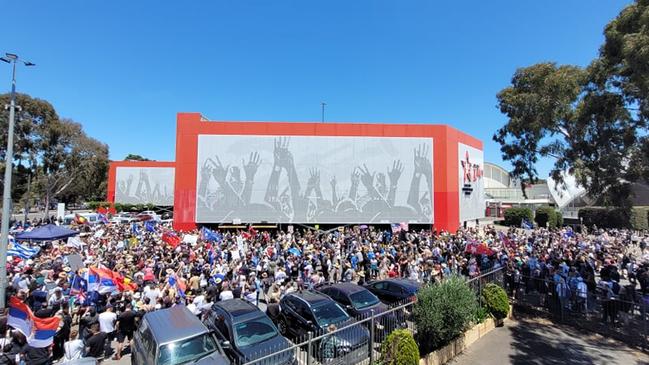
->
<box><xmin>158</xmin><ymin>333</ymin><xmax>217</xmax><ymax>365</ymax></box>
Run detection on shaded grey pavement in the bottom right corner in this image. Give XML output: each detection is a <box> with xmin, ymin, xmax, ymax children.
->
<box><xmin>449</xmin><ymin>318</ymin><xmax>649</xmax><ymax>365</ymax></box>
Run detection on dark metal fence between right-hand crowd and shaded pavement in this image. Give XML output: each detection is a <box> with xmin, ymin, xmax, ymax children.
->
<box><xmin>504</xmin><ymin>274</ymin><xmax>649</xmax><ymax>351</ymax></box>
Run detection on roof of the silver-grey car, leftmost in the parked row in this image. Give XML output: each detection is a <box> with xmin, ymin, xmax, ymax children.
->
<box><xmin>143</xmin><ymin>305</ymin><xmax>209</xmax><ymax>346</ymax></box>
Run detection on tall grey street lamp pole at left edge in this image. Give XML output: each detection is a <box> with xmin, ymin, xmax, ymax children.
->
<box><xmin>0</xmin><ymin>53</ymin><xmax>36</xmax><ymax>309</ymax></box>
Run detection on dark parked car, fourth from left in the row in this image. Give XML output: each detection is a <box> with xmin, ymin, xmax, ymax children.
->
<box><xmin>316</xmin><ymin>283</ymin><xmax>405</xmax><ymax>340</ymax></box>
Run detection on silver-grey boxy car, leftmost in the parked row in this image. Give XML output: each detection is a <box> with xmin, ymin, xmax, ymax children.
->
<box><xmin>131</xmin><ymin>305</ymin><xmax>230</xmax><ymax>365</ymax></box>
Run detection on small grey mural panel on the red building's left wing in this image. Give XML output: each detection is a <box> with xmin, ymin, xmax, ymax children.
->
<box><xmin>115</xmin><ymin>167</ymin><xmax>174</xmax><ymax>206</ymax></box>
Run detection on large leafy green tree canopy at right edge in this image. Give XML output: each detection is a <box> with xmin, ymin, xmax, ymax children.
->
<box><xmin>494</xmin><ymin>0</ymin><xmax>649</xmax><ymax>206</ymax></box>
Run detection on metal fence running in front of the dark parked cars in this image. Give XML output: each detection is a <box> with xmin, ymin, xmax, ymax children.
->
<box><xmin>242</xmin><ymin>301</ymin><xmax>416</xmax><ymax>365</ymax></box>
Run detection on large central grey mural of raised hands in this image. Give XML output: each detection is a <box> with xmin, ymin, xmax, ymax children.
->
<box><xmin>196</xmin><ymin>135</ymin><xmax>433</xmax><ymax>224</ymax></box>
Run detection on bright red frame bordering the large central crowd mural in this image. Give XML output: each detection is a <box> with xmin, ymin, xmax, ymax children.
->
<box><xmin>170</xmin><ymin>113</ymin><xmax>482</xmax><ymax>231</ymax></box>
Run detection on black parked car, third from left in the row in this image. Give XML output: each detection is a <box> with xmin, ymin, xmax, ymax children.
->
<box><xmin>276</xmin><ymin>291</ymin><xmax>370</xmax><ymax>364</ymax></box>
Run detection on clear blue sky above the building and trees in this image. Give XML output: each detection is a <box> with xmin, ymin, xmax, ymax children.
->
<box><xmin>0</xmin><ymin>0</ymin><xmax>631</xmax><ymax>173</ymax></box>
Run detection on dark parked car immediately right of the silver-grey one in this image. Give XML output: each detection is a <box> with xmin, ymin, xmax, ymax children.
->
<box><xmin>205</xmin><ymin>299</ymin><xmax>297</xmax><ymax>365</ymax></box>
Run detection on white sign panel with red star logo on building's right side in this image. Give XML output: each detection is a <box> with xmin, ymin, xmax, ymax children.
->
<box><xmin>458</xmin><ymin>143</ymin><xmax>486</xmax><ymax>223</ymax></box>
